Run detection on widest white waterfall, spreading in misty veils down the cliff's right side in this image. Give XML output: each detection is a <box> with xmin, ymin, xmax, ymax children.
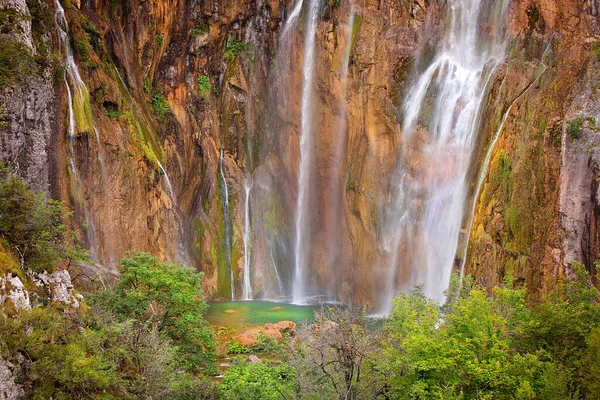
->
<box><xmin>382</xmin><ymin>0</ymin><xmax>508</xmax><ymax>311</ymax></box>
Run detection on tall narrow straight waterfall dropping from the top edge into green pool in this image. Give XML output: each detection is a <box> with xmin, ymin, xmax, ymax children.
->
<box><xmin>293</xmin><ymin>0</ymin><xmax>321</xmax><ymax>303</ymax></box>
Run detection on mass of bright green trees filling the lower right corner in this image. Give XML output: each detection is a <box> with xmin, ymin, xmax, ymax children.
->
<box><xmin>377</xmin><ymin>272</ymin><xmax>600</xmax><ymax>399</ymax></box>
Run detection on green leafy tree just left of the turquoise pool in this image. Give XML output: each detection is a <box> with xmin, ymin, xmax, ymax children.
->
<box><xmin>90</xmin><ymin>253</ymin><xmax>216</xmax><ymax>371</ymax></box>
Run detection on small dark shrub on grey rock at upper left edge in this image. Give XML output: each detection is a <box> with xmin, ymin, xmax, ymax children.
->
<box><xmin>0</xmin><ymin>37</ymin><xmax>35</xmax><ymax>88</ymax></box>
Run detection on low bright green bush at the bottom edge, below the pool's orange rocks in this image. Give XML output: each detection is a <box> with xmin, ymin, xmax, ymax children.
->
<box><xmin>219</xmin><ymin>362</ymin><xmax>296</xmax><ymax>400</ymax></box>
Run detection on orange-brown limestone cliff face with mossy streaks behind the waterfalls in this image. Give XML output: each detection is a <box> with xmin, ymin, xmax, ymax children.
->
<box><xmin>0</xmin><ymin>0</ymin><xmax>600</xmax><ymax>307</ymax></box>
